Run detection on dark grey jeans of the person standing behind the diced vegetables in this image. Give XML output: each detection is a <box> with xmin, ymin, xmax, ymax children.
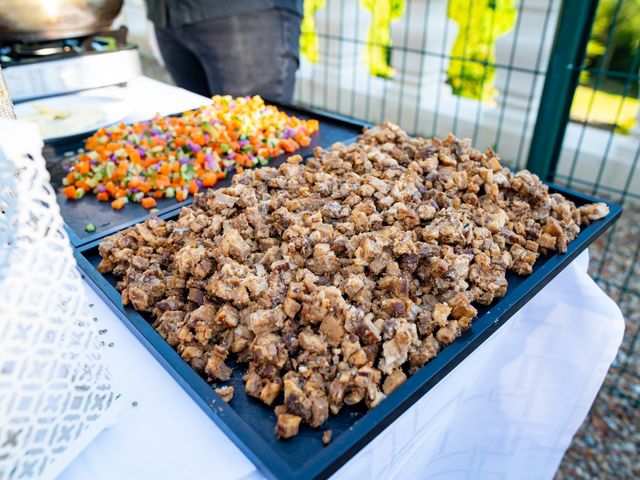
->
<box><xmin>180</xmin><ymin>10</ymin><xmax>302</xmax><ymax>103</ymax></box>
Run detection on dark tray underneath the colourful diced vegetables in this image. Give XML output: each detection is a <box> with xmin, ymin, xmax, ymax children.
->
<box><xmin>43</xmin><ymin>102</ymin><xmax>367</xmax><ymax>247</ymax></box>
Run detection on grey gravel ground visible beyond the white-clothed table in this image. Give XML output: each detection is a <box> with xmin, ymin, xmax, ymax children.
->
<box><xmin>133</xmin><ymin>38</ymin><xmax>640</xmax><ymax>480</ymax></box>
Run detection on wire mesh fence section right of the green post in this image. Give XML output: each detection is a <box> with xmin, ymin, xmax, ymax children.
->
<box><xmin>553</xmin><ymin>0</ymin><xmax>640</xmax><ymax>406</ymax></box>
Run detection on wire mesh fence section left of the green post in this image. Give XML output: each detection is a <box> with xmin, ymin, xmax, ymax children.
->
<box><xmin>296</xmin><ymin>0</ymin><xmax>559</xmax><ymax>171</ymax></box>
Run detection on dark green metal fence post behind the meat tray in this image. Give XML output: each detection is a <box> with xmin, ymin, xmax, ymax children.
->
<box><xmin>527</xmin><ymin>0</ymin><xmax>598</xmax><ymax>180</ymax></box>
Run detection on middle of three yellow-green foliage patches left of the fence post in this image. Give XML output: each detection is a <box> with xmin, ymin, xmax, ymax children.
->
<box><xmin>360</xmin><ymin>0</ymin><xmax>404</xmax><ymax>78</ymax></box>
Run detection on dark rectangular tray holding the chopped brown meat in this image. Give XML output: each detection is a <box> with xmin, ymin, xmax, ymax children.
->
<box><xmin>75</xmin><ymin>181</ymin><xmax>622</xmax><ymax>480</ymax></box>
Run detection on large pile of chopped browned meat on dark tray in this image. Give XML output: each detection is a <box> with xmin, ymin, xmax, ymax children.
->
<box><xmin>99</xmin><ymin>123</ymin><xmax>608</xmax><ymax>441</ymax></box>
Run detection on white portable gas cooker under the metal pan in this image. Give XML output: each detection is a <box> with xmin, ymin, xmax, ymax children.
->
<box><xmin>0</xmin><ymin>27</ymin><xmax>141</xmax><ymax>103</ymax></box>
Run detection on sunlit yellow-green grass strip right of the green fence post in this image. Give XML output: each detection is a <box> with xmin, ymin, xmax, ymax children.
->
<box><xmin>571</xmin><ymin>85</ymin><xmax>639</xmax><ymax>135</ymax></box>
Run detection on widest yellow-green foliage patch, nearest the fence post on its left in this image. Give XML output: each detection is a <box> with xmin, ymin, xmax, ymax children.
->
<box><xmin>447</xmin><ymin>0</ymin><xmax>516</xmax><ymax>100</ymax></box>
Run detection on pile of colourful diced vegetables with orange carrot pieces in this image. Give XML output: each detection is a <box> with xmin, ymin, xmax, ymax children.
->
<box><xmin>63</xmin><ymin>95</ymin><xmax>319</xmax><ymax>210</ymax></box>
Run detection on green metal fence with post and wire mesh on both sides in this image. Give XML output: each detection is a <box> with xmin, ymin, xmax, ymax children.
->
<box><xmin>296</xmin><ymin>0</ymin><xmax>640</xmax><ymax>403</ymax></box>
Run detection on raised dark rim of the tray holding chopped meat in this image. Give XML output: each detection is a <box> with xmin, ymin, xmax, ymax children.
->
<box><xmin>73</xmin><ymin>182</ymin><xmax>622</xmax><ymax>480</ymax></box>
